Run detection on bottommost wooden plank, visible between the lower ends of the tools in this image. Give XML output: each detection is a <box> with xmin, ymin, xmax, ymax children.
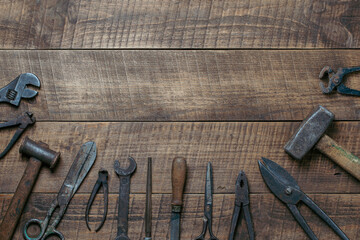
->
<box><xmin>0</xmin><ymin>193</ymin><xmax>360</xmax><ymax>240</ymax></box>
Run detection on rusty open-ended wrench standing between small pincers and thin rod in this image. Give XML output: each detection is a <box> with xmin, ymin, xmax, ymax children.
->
<box><xmin>114</xmin><ymin>156</ymin><xmax>136</xmax><ymax>240</ymax></box>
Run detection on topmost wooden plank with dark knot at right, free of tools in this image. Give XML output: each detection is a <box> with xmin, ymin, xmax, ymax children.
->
<box><xmin>0</xmin><ymin>0</ymin><xmax>360</xmax><ymax>49</ymax></box>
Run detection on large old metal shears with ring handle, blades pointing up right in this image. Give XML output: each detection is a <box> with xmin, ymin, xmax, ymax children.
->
<box><xmin>23</xmin><ymin>142</ymin><xmax>96</xmax><ymax>240</ymax></box>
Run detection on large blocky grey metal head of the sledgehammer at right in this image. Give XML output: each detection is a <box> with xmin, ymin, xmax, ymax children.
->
<box><xmin>284</xmin><ymin>106</ymin><xmax>334</xmax><ymax>160</ymax></box>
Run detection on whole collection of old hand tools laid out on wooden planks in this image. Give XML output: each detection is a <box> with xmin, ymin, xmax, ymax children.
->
<box><xmin>0</xmin><ymin>66</ymin><xmax>360</xmax><ymax>240</ymax></box>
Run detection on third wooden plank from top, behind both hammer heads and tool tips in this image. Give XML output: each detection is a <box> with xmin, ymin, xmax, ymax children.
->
<box><xmin>0</xmin><ymin>122</ymin><xmax>360</xmax><ymax>194</ymax></box>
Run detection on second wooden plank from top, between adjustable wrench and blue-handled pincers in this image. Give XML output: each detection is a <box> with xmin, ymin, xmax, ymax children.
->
<box><xmin>0</xmin><ymin>50</ymin><xmax>360</xmax><ymax>121</ymax></box>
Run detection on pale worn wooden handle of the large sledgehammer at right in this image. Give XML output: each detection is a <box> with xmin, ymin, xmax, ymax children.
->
<box><xmin>315</xmin><ymin>135</ymin><xmax>360</xmax><ymax>181</ymax></box>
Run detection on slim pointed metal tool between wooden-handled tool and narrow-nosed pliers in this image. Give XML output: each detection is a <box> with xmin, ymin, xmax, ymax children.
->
<box><xmin>195</xmin><ymin>162</ymin><xmax>218</xmax><ymax>240</ymax></box>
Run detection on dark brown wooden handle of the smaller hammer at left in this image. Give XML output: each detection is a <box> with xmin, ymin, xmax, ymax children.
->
<box><xmin>0</xmin><ymin>157</ymin><xmax>42</xmax><ymax>240</ymax></box>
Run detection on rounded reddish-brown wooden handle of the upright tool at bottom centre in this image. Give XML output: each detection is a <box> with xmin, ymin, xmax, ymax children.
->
<box><xmin>171</xmin><ymin>157</ymin><xmax>186</xmax><ymax>207</ymax></box>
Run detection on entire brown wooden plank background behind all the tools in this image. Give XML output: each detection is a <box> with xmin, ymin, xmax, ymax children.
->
<box><xmin>0</xmin><ymin>0</ymin><xmax>360</xmax><ymax>240</ymax></box>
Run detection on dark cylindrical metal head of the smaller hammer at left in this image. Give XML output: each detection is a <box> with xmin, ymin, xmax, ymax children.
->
<box><xmin>19</xmin><ymin>137</ymin><xmax>60</xmax><ymax>169</ymax></box>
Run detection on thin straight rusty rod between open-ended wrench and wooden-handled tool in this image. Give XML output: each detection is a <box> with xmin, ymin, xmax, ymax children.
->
<box><xmin>144</xmin><ymin>157</ymin><xmax>152</xmax><ymax>240</ymax></box>
